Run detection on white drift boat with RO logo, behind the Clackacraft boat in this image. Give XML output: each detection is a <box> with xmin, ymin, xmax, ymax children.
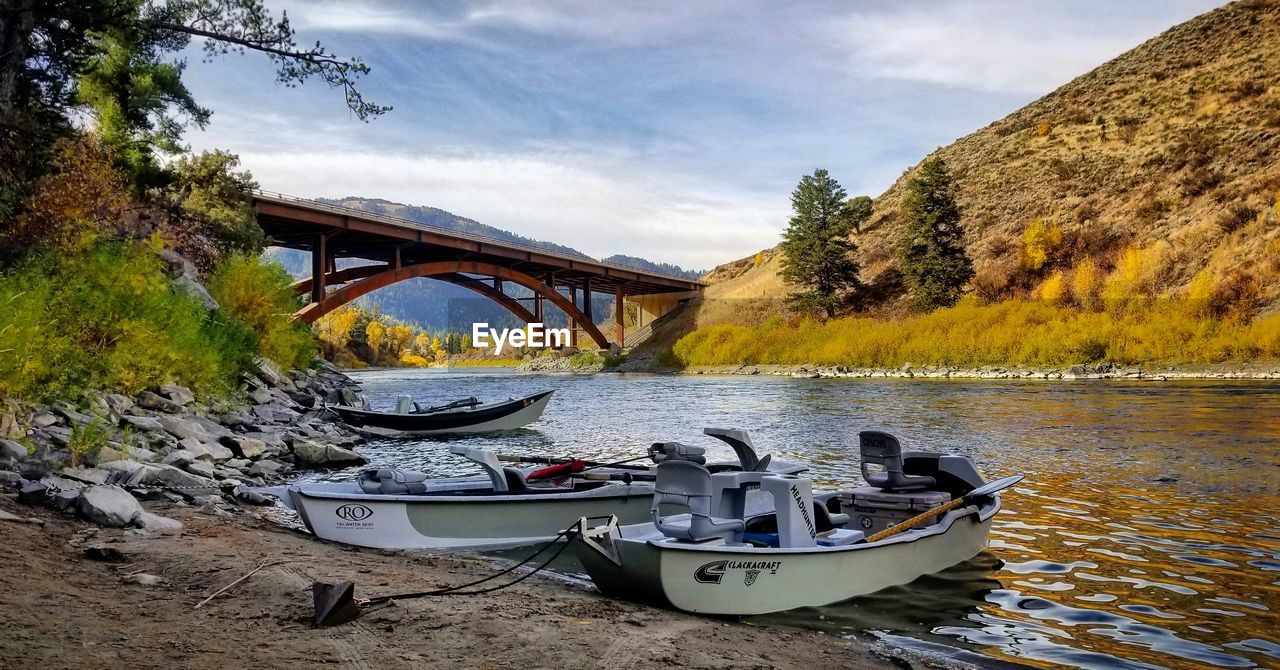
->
<box><xmin>251</xmin><ymin>428</ymin><xmax>805</xmax><ymax>550</ymax></box>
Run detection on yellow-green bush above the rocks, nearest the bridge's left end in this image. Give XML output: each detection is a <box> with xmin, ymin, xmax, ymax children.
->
<box><xmin>209</xmin><ymin>254</ymin><xmax>316</xmax><ymax>369</ymax></box>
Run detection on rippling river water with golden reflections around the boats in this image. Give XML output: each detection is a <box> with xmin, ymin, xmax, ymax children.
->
<box><xmin>312</xmin><ymin>370</ymin><xmax>1280</xmax><ymax>667</ymax></box>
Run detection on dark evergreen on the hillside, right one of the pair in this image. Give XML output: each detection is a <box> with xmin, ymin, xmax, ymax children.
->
<box><xmin>901</xmin><ymin>158</ymin><xmax>973</xmax><ymax>310</ymax></box>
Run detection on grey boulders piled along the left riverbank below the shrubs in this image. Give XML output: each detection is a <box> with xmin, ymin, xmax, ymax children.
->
<box><xmin>0</xmin><ymin>360</ymin><xmax>366</xmax><ymax>532</ymax></box>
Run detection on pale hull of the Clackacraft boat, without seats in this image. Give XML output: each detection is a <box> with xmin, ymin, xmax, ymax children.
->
<box><xmin>575</xmin><ymin>500</ymin><xmax>1000</xmax><ymax>615</ymax></box>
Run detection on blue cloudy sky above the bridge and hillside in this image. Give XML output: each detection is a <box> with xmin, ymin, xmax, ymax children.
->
<box><xmin>187</xmin><ymin>0</ymin><xmax>1217</xmax><ymax>269</ymax></box>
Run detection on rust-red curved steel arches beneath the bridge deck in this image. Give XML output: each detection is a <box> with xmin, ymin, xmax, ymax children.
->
<box><xmin>293</xmin><ymin>260</ymin><xmax>609</xmax><ymax>348</ymax></box>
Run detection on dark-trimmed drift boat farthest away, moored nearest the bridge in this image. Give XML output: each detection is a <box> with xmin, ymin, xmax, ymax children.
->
<box><xmin>329</xmin><ymin>391</ymin><xmax>553</xmax><ymax>437</ymax></box>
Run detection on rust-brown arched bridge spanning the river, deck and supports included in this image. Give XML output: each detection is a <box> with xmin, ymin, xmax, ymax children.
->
<box><xmin>253</xmin><ymin>191</ymin><xmax>704</xmax><ymax>348</ymax></box>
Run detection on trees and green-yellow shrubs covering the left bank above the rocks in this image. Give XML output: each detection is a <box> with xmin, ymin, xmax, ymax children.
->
<box><xmin>0</xmin><ymin>0</ymin><xmax>387</xmax><ymax>401</ymax></box>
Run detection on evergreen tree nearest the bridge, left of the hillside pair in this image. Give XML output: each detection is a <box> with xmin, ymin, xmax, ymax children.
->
<box><xmin>782</xmin><ymin>169</ymin><xmax>859</xmax><ymax>318</ymax></box>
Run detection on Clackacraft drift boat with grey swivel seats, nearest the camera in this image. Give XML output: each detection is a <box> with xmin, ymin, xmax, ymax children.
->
<box><xmin>575</xmin><ymin>432</ymin><xmax>1020</xmax><ymax>615</ymax></box>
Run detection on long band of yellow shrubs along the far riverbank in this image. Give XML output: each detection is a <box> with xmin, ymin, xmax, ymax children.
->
<box><xmin>659</xmin><ymin>297</ymin><xmax>1280</xmax><ymax>368</ymax></box>
